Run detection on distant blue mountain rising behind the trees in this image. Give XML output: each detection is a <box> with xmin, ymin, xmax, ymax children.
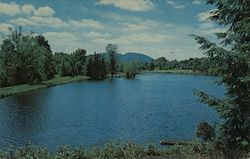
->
<box><xmin>102</xmin><ymin>52</ymin><xmax>154</xmax><ymax>62</ymax></box>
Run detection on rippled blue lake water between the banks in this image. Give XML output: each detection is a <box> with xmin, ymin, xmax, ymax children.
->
<box><xmin>0</xmin><ymin>73</ymin><xmax>224</xmax><ymax>149</ymax></box>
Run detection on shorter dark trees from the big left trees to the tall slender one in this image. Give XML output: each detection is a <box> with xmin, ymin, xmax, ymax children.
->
<box><xmin>54</xmin><ymin>44</ymin><xmax>118</xmax><ymax>79</ymax></box>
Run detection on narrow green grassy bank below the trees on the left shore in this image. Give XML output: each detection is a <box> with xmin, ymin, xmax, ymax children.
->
<box><xmin>0</xmin><ymin>76</ymin><xmax>88</xmax><ymax>98</ymax></box>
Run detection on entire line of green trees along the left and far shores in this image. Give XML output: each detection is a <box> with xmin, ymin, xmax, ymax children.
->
<box><xmin>0</xmin><ymin>27</ymin><xmax>225</xmax><ymax>87</ymax></box>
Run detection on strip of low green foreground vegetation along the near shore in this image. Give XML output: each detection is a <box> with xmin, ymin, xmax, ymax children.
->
<box><xmin>0</xmin><ymin>142</ymin><xmax>229</xmax><ymax>159</ymax></box>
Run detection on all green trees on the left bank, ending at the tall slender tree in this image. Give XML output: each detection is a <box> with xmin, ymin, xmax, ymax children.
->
<box><xmin>0</xmin><ymin>27</ymin><xmax>123</xmax><ymax>87</ymax></box>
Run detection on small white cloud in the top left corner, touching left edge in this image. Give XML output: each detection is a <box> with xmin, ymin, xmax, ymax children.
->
<box><xmin>0</xmin><ymin>2</ymin><xmax>21</xmax><ymax>16</ymax></box>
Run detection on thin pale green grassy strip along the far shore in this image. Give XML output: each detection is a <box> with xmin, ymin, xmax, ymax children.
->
<box><xmin>142</xmin><ymin>69</ymin><xmax>205</xmax><ymax>75</ymax></box>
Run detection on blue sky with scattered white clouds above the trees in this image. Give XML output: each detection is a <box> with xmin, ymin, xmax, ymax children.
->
<box><xmin>0</xmin><ymin>0</ymin><xmax>226</xmax><ymax>60</ymax></box>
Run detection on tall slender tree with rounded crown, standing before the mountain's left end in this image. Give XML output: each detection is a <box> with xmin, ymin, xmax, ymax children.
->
<box><xmin>105</xmin><ymin>44</ymin><xmax>118</xmax><ymax>78</ymax></box>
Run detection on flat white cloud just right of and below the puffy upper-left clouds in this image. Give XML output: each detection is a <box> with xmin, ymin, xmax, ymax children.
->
<box><xmin>69</xmin><ymin>19</ymin><xmax>104</xmax><ymax>29</ymax></box>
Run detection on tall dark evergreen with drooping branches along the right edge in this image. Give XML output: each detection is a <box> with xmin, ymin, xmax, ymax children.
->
<box><xmin>194</xmin><ymin>0</ymin><xmax>250</xmax><ymax>158</ymax></box>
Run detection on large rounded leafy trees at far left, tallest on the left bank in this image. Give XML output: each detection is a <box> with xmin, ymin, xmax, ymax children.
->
<box><xmin>0</xmin><ymin>27</ymin><xmax>56</xmax><ymax>86</ymax></box>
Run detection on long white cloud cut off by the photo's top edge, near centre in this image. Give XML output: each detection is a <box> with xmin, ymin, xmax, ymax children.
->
<box><xmin>97</xmin><ymin>0</ymin><xmax>155</xmax><ymax>12</ymax></box>
